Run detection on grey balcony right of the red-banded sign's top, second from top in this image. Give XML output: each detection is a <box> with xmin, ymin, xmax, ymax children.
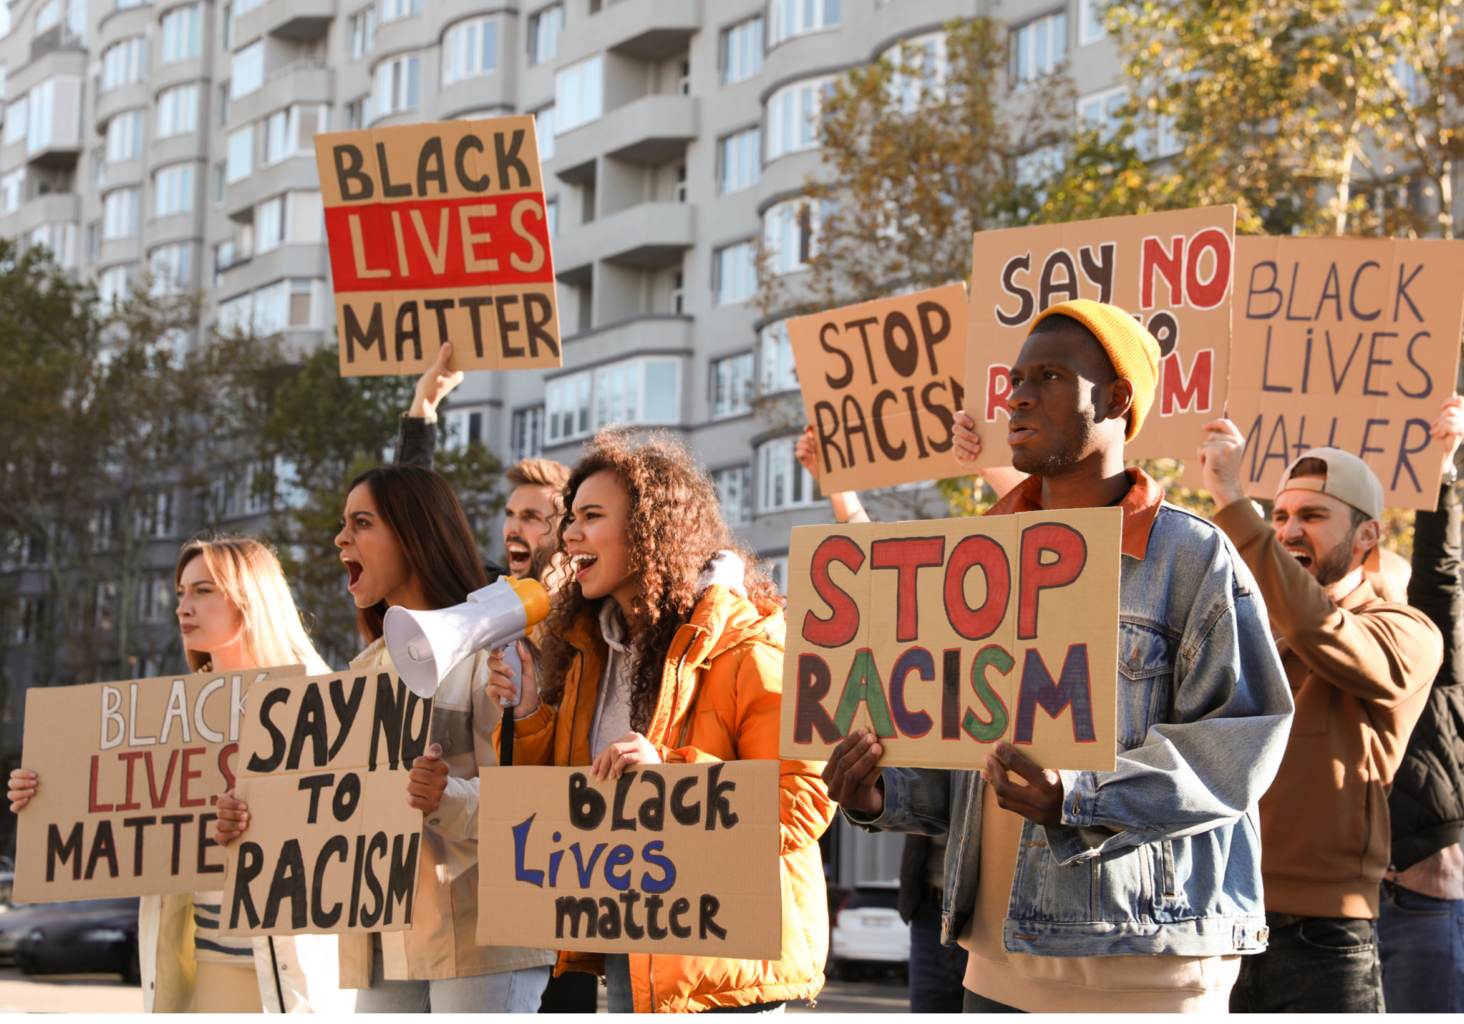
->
<box><xmin>553</xmin><ymin>95</ymin><xmax>700</xmax><ymax>182</ymax></box>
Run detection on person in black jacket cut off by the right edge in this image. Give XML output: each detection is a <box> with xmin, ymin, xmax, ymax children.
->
<box><xmin>1378</xmin><ymin>396</ymin><xmax>1464</xmax><ymax>1014</ymax></box>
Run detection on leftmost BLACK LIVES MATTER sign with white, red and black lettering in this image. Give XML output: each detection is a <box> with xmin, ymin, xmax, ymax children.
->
<box><xmin>15</xmin><ymin>665</ymin><xmax>305</xmax><ymax>902</ymax></box>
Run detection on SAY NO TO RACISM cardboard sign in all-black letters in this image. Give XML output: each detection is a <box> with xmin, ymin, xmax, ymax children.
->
<box><xmin>221</xmin><ymin>668</ymin><xmax>432</xmax><ymax>935</ymax></box>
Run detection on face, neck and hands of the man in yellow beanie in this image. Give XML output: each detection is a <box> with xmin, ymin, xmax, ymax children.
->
<box><xmin>823</xmin><ymin>331</ymin><xmax>1133</xmax><ymax>825</ymax></box>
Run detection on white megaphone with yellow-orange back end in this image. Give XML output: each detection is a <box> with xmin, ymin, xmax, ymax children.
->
<box><xmin>384</xmin><ymin>576</ymin><xmax>549</xmax><ymax>697</ymax></box>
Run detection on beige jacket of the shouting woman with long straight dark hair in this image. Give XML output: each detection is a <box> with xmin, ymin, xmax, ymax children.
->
<box><xmin>340</xmin><ymin>640</ymin><xmax>555</xmax><ymax>989</ymax></box>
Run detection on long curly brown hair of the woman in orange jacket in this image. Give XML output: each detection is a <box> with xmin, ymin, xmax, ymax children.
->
<box><xmin>540</xmin><ymin>431</ymin><xmax>779</xmax><ymax>732</ymax></box>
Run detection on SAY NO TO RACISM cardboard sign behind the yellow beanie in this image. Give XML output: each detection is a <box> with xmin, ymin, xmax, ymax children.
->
<box><xmin>966</xmin><ymin>207</ymin><xmax>1236</xmax><ymax>466</ymax></box>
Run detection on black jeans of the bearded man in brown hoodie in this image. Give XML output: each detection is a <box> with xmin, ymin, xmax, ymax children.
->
<box><xmin>1230</xmin><ymin>914</ymin><xmax>1383</xmax><ymax>1014</ymax></box>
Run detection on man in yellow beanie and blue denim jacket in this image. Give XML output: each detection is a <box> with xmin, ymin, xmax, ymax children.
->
<box><xmin>824</xmin><ymin>300</ymin><xmax>1291</xmax><ymax>1012</ymax></box>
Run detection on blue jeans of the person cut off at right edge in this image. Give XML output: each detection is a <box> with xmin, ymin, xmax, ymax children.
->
<box><xmin>1378</xmin><ymin>882</ymin><xmax>1464</xmax><ymax>1014</ymax></box>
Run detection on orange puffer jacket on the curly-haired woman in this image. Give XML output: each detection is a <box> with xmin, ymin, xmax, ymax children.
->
<box><xmin>495</xmin><ymin>586</ymin><xmax>834</xmax><ymax>1014</ymax></box>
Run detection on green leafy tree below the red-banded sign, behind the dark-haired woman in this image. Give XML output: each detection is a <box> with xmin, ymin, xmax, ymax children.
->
<box><xmin>256</xmin><ymin>344</ymin><xmax>504</xmax><ymax>665</ymax></box>
